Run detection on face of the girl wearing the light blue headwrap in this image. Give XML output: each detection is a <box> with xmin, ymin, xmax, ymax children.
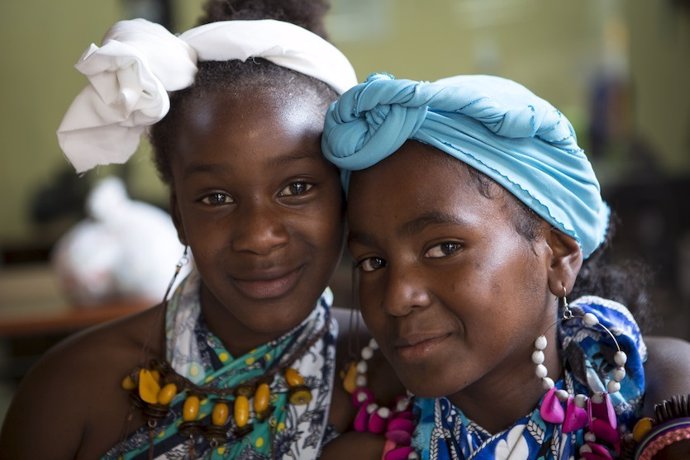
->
<box><xmin>348</xmin><ymin>141</ymin><xmax>556</xmax><ymax>407</ymax></box>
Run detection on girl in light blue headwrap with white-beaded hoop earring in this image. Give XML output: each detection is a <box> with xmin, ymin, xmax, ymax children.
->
<box><xmin>322</xmin><ymin>74</ymin><xmax>690</xmax><ymax>459</ymax></box>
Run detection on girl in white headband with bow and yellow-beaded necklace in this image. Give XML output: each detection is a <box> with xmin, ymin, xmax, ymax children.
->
<box><xmin>0</xmin><ymin>1</ymin><xmax>404</xmax><ymax>459</ymax></box>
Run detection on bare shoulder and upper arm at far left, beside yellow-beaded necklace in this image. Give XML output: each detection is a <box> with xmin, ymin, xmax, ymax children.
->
<box><xmin>0</xmin><ymin>306</ymin><xmax>164</xmax><ymax>458</ymax></box>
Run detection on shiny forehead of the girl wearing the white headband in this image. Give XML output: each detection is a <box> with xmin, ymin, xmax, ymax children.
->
<box><xmin>172</xmin><ymin>87</ymin><xmax>325</xmax><ymax>166</ymax></box>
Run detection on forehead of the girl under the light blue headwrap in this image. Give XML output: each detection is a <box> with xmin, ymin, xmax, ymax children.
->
<box><xmin>348</xmin><ymin>141</ymin><xmax>510</xmax><ymax>231</ymax></box>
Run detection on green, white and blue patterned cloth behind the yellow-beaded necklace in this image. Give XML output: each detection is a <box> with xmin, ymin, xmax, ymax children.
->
<box><xmin>103</xmin><ymin>271</ymin><xmax>338</xmax><ymax>460</ymax></box>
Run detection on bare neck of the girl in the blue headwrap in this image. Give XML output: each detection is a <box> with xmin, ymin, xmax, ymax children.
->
<box><xmin>449</xmin><ymin>331</ymin><xmax>562</xmax><ymax>434</ymax></box>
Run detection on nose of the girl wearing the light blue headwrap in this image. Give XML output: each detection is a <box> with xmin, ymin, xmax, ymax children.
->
<box><xmin>381</xmin><ymin>264</ymin><xmax>431</xmax><ymax>316</ymax></box>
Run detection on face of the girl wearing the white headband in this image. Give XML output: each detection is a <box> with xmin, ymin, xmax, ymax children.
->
<box><xmin>171</xmin><ymin>88</ymin><xmax>343</xmax><ymax>352</ymax></box>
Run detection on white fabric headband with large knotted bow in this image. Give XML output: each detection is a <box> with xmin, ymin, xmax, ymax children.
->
<box><xmin>57</xmin><ymin>19</ymin><xmax>357</xmax><ymax>173</ymax></box>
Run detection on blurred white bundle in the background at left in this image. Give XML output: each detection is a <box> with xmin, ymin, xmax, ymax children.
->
<box><xmin>52</xmin><ymin>177</ymin><xmax>190</xmax><ymax>305</ymax></box>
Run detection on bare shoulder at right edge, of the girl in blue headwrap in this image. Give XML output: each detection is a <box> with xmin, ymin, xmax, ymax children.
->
<box><xmin>645</xmin><ymin>336</ymin><xmax>690</xmax><ymax>414</ymax></box>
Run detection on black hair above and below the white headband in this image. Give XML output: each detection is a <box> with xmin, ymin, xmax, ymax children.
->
<box><xmin>149</xmin><ymin>0</ymin><xmax>338</xmax><ymax>185</ymax></box>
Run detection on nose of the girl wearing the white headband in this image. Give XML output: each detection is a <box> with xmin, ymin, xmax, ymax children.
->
<box><xmin>232</xmin><ymin>202</ymin><xmax>289</xmax><ymax>255</ymax></box>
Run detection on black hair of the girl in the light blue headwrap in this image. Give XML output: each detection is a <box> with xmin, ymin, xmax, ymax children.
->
<box><xmin>462</xmin><ymin>163</ymin><xmax>651</xmax><ymax>328</ymax></box>
